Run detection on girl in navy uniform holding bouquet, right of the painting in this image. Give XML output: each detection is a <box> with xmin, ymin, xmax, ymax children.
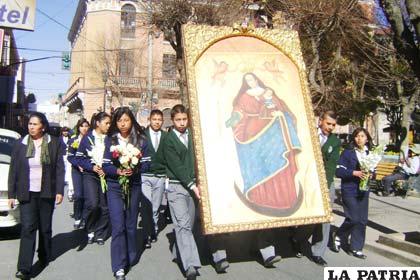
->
<box><xmin>332</xmin><ymin>128</ymin><xmax>372</xmax><ymax>259</ymax></box>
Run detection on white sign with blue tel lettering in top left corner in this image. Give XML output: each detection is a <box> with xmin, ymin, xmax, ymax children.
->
<box><xmin>0</xmin><ymin>0</ymin><xmax>36</xmax><ymax>31</ymax></box>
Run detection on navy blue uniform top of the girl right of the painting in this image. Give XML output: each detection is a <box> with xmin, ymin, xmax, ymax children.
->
<box><xmin>335</xmin><ymin>149</ymin><xmax>368</xmax><ymax>195</ymax></box>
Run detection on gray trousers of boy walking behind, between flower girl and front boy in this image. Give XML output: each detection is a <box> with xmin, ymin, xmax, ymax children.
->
<box><xmin>141</xmin><ymin>175</ymin><xmax>165</xmax><ymax>239</ymax></box>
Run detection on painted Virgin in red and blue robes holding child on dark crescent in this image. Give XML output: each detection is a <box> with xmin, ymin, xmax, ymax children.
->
<box><xmin>225</xmin><ymin>73</ymin><xmax>303</xmax><ymax>216</ymax></box>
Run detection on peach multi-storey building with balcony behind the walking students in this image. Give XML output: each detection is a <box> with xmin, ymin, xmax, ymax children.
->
<box><xmin>61</xmin><ymin>0</ymin><xmax>180</xmax><ymax>126</ymax></box>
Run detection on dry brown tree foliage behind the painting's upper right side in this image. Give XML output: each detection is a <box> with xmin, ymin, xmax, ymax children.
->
<box><xmin>266</xmin><ymin>0</ymin><xmax>404</xmax><ymax>125</ymax></box>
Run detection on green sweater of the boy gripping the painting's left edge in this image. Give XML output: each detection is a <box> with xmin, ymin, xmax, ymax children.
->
<box><xmin>162</xmin><ymin>130</ymin><xmax>195</xmax><ymax>189</ymax></box>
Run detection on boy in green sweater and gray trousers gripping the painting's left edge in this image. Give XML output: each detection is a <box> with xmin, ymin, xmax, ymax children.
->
<box><xmin>162</xmin><ymin>104</ymin><xmax>201</xmax><ymax>280</ymax></box>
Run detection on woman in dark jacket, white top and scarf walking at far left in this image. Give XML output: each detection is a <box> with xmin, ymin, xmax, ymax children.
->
<box><xmin>9</xmin><ymin>112</ymin><xmax>64</xmax><ymax>279</ymax></box>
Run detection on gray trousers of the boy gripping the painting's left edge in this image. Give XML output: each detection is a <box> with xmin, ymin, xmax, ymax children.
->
<box><xmin>167</xmin><ymin>183</ymin><xmax>201</xmax><ymax>270</ymax></box>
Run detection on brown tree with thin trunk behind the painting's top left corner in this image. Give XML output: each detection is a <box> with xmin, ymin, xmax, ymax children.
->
<box><xmin>149</xmin><ymin>0</ymin><xmax>244</xmax><ymax>104</ymax></box>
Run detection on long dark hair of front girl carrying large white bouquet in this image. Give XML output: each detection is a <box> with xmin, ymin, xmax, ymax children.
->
<box><xmin>109</xmin><ymin>107</ymin><xmax>146</xmax><ymax>147</ymax></box>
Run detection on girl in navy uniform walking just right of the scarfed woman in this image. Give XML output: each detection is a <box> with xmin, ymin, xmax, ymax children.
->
<box><xmin>67</xmin><ymin>118</ymin><xmax>90</xmax><ymax>229</ymax></box>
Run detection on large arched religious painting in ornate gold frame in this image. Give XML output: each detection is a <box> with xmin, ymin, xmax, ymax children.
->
<box><xmin>182</xmin><ymin>25</ymin><xmax>331</xmax><ymax>234</ymax></box>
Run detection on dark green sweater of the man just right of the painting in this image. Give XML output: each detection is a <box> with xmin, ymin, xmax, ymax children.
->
<box><xmin>321</xmin><ymin>134</ymin><xmax>341</xmax><ymax>188</ymax></box>
